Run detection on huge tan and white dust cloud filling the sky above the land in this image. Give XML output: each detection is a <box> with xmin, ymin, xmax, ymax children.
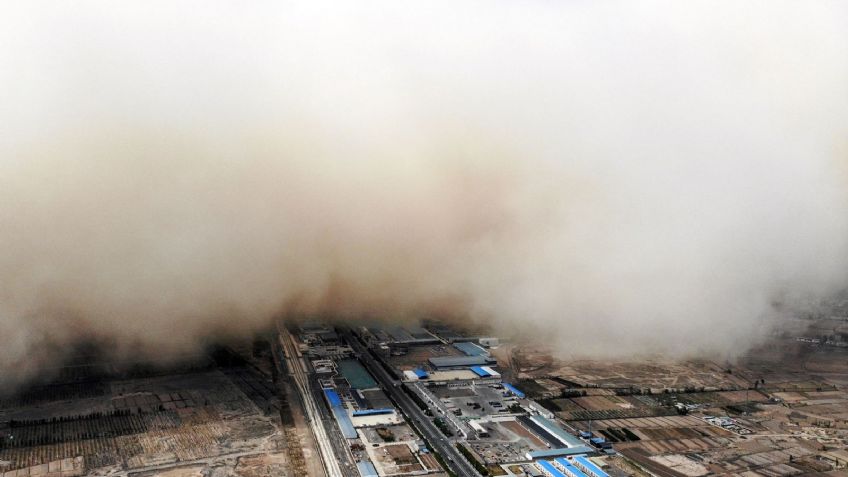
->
<box><xmin>0</xmin><ymin>0</ymin><xmax>848</xmax><ymax>384</ymax></box>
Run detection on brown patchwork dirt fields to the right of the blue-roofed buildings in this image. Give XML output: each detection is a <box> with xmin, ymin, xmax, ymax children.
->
<box><xmin>511</xmin><ymin>319</ymin><xmax>848</xmax><ymax>477</ymax></box>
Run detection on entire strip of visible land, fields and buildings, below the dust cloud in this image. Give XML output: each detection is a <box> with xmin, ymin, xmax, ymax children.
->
<box><xmin>0</xmin><ymin>312</ymin><xmax>848</xmax><ymax>477</ymax></box>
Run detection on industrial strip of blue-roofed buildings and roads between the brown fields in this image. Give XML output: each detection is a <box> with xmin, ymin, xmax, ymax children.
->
<box><xmin>270</xmin><ymin>322</ymin><xmax>615</xmax><ymax>477</ymax></box>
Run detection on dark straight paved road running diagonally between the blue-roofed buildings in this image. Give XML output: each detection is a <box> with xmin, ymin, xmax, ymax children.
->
<box><xmin>339</xmin><ymin>327</ymin><xmax>480</xmax><ymax>477</ymax></box>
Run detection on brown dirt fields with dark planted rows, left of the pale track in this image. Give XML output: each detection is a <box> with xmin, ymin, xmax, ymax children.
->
<box><xmin>0</xmin><ymin>342</ymin><xmax>302</xmax><ymax>477</ymax></box>
